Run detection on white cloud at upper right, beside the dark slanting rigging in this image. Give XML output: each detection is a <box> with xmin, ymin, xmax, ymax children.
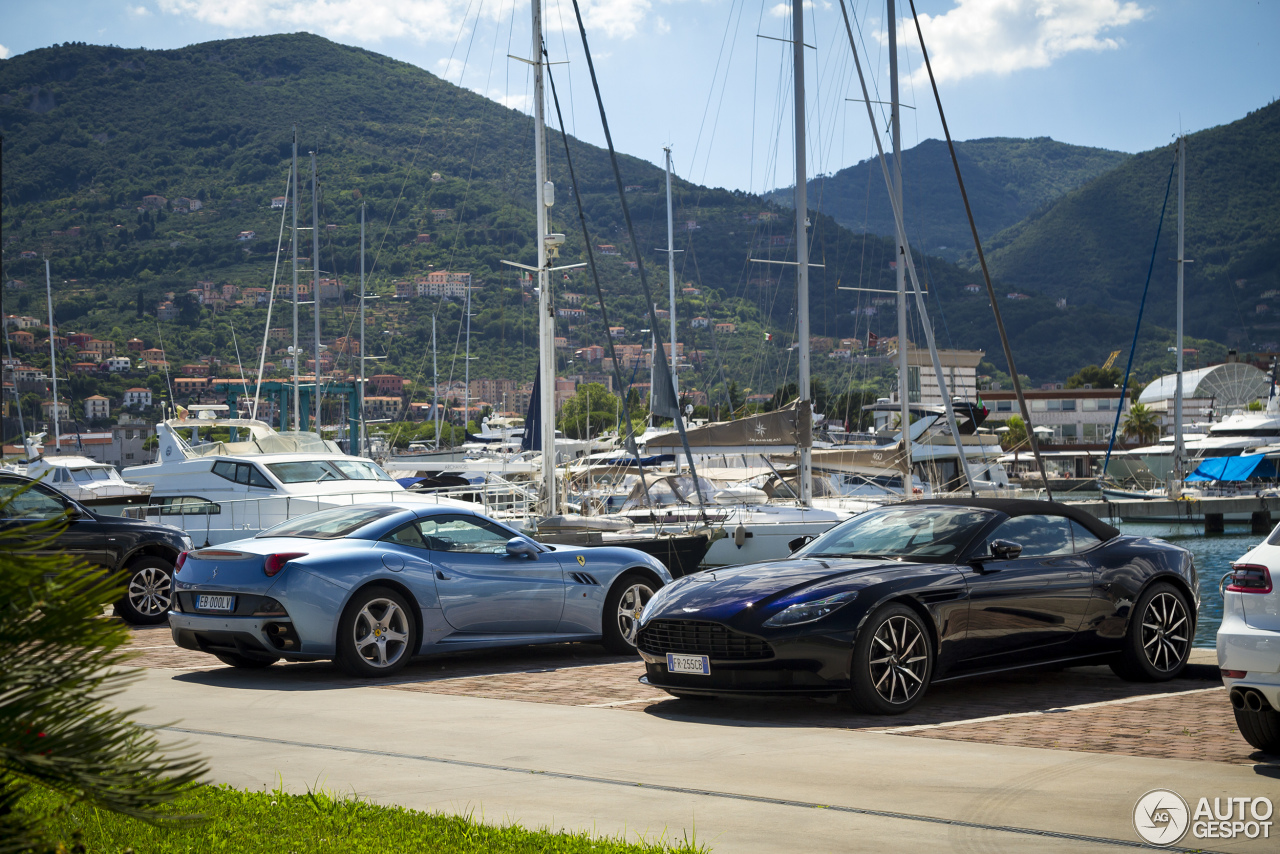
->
<box><xmin>899</xmin><ymin>0</ymin><xmax>1147</xmax><ymax>85</ymax></box>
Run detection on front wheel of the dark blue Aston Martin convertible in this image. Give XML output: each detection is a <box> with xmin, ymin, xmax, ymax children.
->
<box><xmin>850</xmin><ymin>602</ymin><xmax>933</xmax><ymax>714</ymax></box>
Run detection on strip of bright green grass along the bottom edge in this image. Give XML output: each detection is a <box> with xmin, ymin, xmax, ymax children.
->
<box><xmin>20</xmin><ymin>786</ymin><xmax>707</xmax><ymax>854</ymax></box>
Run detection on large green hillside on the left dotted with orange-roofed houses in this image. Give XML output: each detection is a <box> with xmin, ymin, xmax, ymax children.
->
<box><xmin>0</xmin><ymin>35</ymin><xmax>1239</xmax><ymax>427</ymax></box>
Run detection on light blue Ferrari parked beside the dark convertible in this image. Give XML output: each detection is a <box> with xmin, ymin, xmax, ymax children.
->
<box><xmin>169</xmin><ymin>504</ymin><xmax>671</xmax><ymax>676</ymax></box>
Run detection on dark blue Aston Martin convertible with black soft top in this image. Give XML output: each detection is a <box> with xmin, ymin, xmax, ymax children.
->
<box><xmin>637</xmin><ymin>498</ymin><xmax>1198</xmax><ymax>714</ymax></box>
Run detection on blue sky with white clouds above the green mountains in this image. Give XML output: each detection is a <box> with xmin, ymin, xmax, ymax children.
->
<box><xmin>0</xmin><ymin>0</ymin><xmax>1280</xmax><ymax>192</ymax></box>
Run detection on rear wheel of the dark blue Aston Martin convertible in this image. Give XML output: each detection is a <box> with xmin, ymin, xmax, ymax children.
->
<box><xmin>1111</xmin><ymin>581</ymin><xmax>1196</xmax><ymax>682</ymax></box>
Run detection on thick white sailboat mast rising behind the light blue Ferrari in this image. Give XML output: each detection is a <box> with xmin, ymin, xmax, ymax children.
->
<box><xmin>530</xmin><ymin>0</ymin><xmax>557</xmax><ymax>516</ymax></box>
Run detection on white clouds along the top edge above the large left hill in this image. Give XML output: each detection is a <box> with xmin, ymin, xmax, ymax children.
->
<box><xmin>157</xmin><ymin>0</ymin><xmax>653</xmax><ymax>42</ymax></box>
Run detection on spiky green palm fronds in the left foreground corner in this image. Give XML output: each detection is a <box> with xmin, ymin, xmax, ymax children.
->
<box><xmin>0</xmin><ymin>490</ymin><xmax>205</xmax><ymax>854</ymax></box>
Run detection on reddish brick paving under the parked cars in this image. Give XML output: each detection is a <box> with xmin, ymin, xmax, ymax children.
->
<box><xmin>122</xmin><ymin>627</ymin><xmax>1280</xmax><ymax>767</ymax></box>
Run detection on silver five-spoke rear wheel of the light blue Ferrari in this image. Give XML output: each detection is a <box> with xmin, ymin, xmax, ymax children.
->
<box><xmin>338</xmin><ymin>588</ymin><xmax>415</xmax><ymax>676</ymax></box>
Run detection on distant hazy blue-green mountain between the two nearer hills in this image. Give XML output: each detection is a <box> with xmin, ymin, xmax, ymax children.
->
<box><xmin>768</xmin><ymin>137</ymin><xmax>1129</xmax><ymax>260</ymax></box>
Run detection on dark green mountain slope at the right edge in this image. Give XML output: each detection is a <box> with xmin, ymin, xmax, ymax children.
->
<box><xmin>988</xmin><ymin>101</ymin><xmax>1280</xmax><ymax>351</ymax></box>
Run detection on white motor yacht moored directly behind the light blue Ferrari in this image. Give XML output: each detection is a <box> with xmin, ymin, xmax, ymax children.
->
<box><xmin>124</xmin><ymin>407</ymin><xmax>480</xmax><ymax>545</ymax></box>
